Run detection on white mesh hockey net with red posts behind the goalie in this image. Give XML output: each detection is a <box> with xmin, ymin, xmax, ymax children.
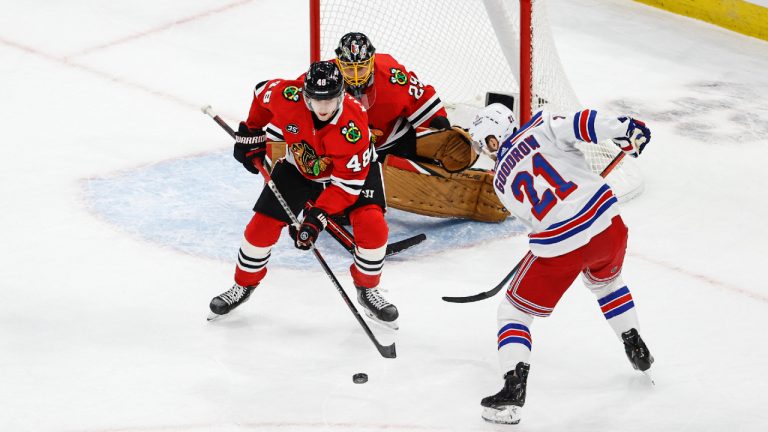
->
<box><xmin>311</xmin><ymin>0</ymin><xmax>643</xmax><ymax>200</ymax></box>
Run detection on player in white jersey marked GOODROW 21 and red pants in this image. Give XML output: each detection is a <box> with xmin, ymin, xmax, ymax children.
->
<box><xmin>469</xmin><ymin>104</ymin><xmax>653</xmax><ymax>424</ymax></box>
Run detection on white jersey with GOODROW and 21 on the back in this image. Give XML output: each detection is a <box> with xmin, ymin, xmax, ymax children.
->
<box><xmin>494</xmin><ymin>110</ymin><xmax>628</xmax><ymax>257</ymax></box>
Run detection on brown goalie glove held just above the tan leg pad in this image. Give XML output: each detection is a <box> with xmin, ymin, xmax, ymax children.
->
<box><xmin>416</xmin><ymin>127</ymin><xmax>478</xmax><ymax>173</ymax></box>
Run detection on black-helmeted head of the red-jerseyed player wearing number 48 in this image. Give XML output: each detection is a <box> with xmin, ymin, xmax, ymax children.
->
<box><xmin>303</xmin><ymin>61</ymin><xmax>344</xmax><ymax>121</ymax></box>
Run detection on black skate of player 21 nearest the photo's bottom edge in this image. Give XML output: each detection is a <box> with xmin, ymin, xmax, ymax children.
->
<box><xmin>480</xmin><ymin>362</ymin><xmax>530</xmax><ymax>424</ymax></box>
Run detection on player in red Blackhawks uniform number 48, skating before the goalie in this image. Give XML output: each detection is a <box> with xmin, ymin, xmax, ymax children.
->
<box><xmin>210</xmin><ymin>62</ymin><xmax>398</xmax><ymax>328</ymax></box>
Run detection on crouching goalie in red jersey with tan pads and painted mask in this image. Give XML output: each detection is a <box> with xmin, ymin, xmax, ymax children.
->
<box><xmin>335</xmin><ymin>32</ymin><xmax>509</xmax><ymax>222</ymax></box>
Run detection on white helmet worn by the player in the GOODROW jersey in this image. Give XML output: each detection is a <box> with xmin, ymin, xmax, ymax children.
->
<box><xmin>469</xmin><ymin>103</ymin><xmax>518</xmax><ymax>159</ymax></box>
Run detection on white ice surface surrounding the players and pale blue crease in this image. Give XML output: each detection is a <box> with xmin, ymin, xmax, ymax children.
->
<box><xmin>0</xmin><ymin>0</ymin><xmax>768</xmax><ymax>432</ymax></box>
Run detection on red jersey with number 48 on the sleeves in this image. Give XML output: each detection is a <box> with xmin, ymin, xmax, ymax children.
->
<box><xmin>246</xmin><ymin>79</ymin><xmax>374</xmax><ymax>214</ymax></box>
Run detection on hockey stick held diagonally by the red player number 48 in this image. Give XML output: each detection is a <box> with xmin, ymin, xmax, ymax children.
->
<box><xmin>203</xmin><ymin>106</ymin><xmax>397</xmax><ymax>358</ymax></box>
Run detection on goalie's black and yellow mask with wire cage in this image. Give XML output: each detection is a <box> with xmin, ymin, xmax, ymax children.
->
<box><xmin>336</xmin><ymin>32</ymin><xmax>376</xmax><ymax>89</ymax></box>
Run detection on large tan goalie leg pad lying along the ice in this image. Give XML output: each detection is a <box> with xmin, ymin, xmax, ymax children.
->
<box><xmin>384</xmin><ymin>155</ymin><xmax>509</xmax><ymax>222</ymax></box>
